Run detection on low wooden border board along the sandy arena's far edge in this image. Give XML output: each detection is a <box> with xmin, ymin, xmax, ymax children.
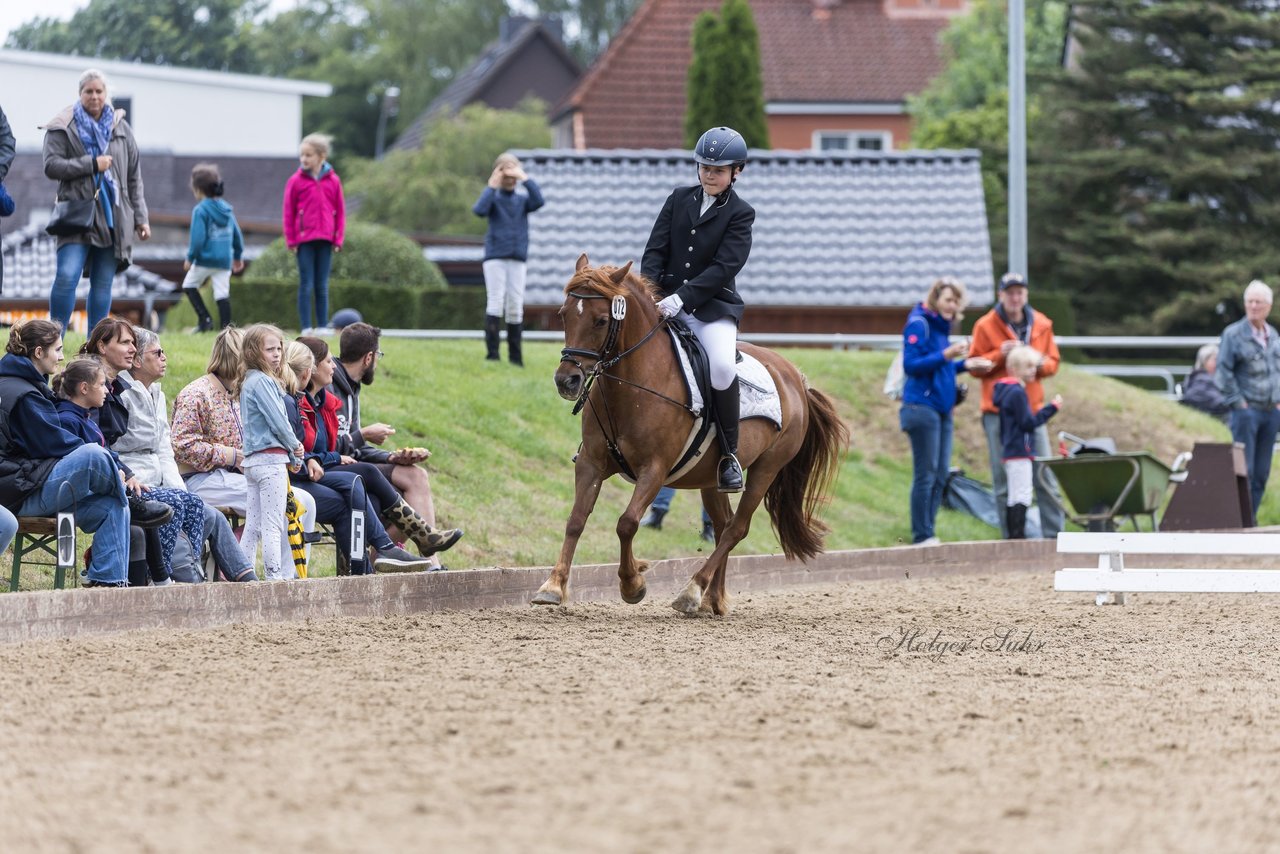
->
<box><xmin>0</xmin><ymin>540</ymin><xmax>1061</xmax><ymax>643</ymax></box>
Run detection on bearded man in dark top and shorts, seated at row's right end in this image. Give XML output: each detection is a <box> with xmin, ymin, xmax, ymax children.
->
<box><xmin>329</xmin><ymin>323</ymin><xmax>460</xmax><ymax>561</ymax></box>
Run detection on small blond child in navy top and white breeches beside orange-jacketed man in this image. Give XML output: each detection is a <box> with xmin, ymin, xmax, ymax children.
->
<box><xmin>991</xmin><ymin>344</ymin><xmax>1062</xmax><ymax>540</ymax></box>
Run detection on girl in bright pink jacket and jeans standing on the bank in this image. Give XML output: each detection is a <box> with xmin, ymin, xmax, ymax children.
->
<box><xmin>283</xmin><ymin>133</ymin><xmax>347</xmax><ymax>329</ymax></box>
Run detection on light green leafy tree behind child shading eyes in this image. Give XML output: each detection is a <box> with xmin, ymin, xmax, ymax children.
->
<box><xmin>346</xmin><ymin>99</ymin><xmax>552</xmax><ymax>234</ymax></box>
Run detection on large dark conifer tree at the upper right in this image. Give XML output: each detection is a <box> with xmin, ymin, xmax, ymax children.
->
<box><xmin>1029</xmin><ymin>0</ymin><xmax>1280</xmax><ymax>333</ymax></box>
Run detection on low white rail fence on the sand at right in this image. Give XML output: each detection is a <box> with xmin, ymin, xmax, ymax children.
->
<box><xmin>1053</xmin><ymin>531</ymin><xmax>1280</xmax><ymax>604</ymax></box>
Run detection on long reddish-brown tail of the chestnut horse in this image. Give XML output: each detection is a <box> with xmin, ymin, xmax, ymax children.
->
<box><xmin>764</xmin><ymin>388</ymin><xmax>849</xmax><ymax>561</ymax></box>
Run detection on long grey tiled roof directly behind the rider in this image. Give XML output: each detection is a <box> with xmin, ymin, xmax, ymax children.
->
<box><xmin>504</xmin><ymin>149</ymin><xmax>995</xmax><ymax>306</ymax></box>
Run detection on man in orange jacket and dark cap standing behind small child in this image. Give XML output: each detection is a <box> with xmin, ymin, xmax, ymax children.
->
<box><xmin>969</xmin><ymin>273</ymin><xmax>1062</xmax><ymax>538</ymax></box>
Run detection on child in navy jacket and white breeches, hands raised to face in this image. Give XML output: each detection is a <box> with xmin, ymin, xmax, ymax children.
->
<box><xmin>471</xmin><ymin>154</ymin><xmax>543</xmax><ymax>365</ymax></box>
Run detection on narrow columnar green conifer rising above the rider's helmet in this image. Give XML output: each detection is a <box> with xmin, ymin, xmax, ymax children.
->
<box><xmin>685</xmin><ymin>0</ymin><xmax>769</xmax><ymax>149</ymax></box>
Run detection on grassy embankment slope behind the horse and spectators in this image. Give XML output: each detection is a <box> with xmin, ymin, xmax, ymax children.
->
<box><xmin>23</xmin><ymin>332</ymin><xmax>1259</xmax><ymax>586</ymax></box>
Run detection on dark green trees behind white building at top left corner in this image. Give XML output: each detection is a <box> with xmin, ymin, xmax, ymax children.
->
<box><xmin>5</xmin><ymin>0</ymin><xmax>268</xmax><ymax>72</ymax></box>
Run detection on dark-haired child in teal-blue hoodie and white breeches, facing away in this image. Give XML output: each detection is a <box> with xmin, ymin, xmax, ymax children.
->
<box><xmin>182</xmin><ymin>163</ymin><xmax>244</xmax><ymax>332</ymax></box>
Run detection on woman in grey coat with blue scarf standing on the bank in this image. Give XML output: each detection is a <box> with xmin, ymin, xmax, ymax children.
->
<box><xmin>44</xmin><ymin>69</ymin><xmax>151</xmax><ymax>329</ymax></box>
